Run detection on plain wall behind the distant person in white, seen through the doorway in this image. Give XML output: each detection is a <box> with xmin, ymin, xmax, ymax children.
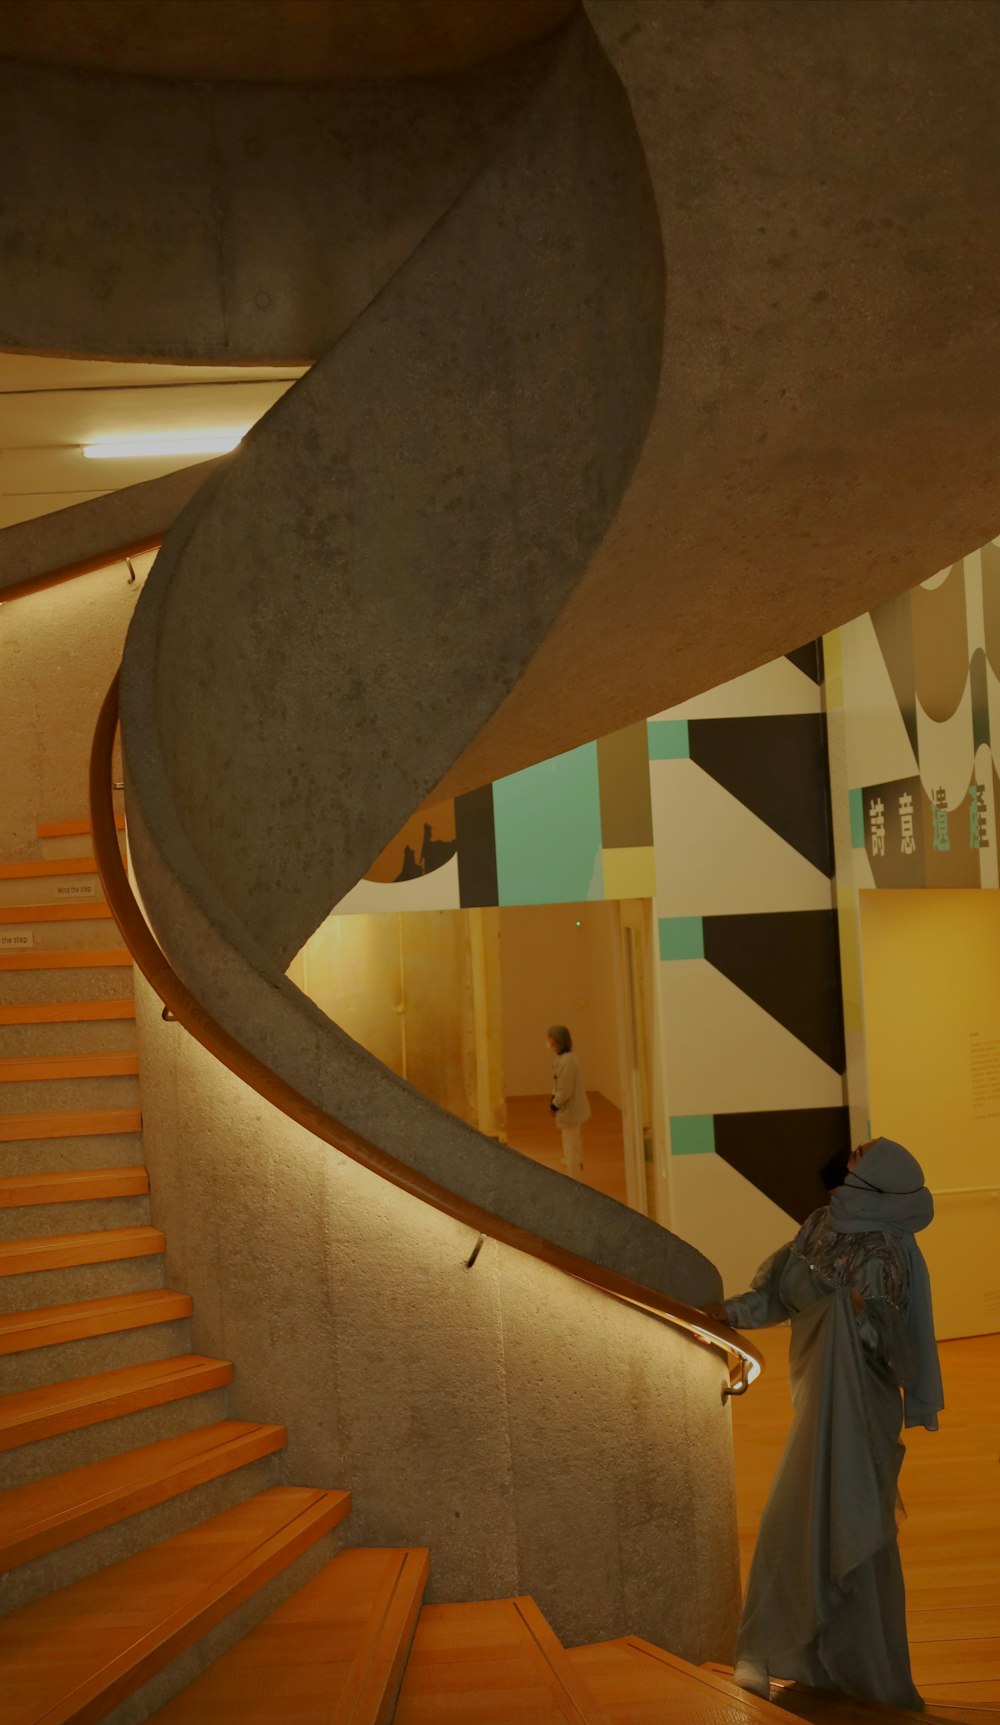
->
<box><xmin>500</xmin><ymin>904</ymin><xmax>621</xmax><ymax>1107</ymax></box>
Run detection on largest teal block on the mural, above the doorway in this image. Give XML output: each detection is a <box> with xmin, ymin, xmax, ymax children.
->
<box><xmin>493</xmin><ymin>743</ymin><xmax>603</xmax><ymax>904</ymax></box>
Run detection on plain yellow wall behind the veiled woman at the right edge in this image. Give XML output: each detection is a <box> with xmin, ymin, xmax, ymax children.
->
<box><xmin>860</xmin><ymin>890</ymin><xmax>1000</xmax><ymax>1337</ymax></box>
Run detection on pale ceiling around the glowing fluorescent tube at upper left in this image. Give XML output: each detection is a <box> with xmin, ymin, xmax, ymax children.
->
<box><xmin>0</xmin><ymin>354</ymin><xmax>302</xmax><ymax>528</ymax></box>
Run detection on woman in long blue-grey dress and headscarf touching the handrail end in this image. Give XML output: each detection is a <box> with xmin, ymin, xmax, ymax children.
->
<box><xmin>712</xmin><ymin>1139</ymin><xmax>943</xmax><ymax>1708</ymax></box>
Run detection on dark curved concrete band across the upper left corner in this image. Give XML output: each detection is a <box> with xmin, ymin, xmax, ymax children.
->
<box><xmin>0</xmin><ymin>36</ymin><xmax>550</xmax><ymax>364</ymax></box>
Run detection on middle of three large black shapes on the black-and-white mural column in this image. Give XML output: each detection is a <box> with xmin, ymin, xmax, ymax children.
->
<box><xmin>702</xmin><ymin>911</ymin><xmax>845</xmax><ymax>1073</ymax></box>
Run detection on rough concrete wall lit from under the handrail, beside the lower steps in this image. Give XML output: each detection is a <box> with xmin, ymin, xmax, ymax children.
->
<box><xmin>140</xmin><ymin>987</ymin><xmax>738</xmax><ymax>1659</ymax></box>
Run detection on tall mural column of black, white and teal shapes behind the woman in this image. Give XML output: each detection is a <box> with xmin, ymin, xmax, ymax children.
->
<box><xmin>650</xmin><ymin>643</ymin><xmax>848</xmax><ymax>1268</ymax></box>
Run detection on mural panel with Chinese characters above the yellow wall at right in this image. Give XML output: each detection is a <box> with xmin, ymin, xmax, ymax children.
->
<box><xmin>840</xmin><ymin>543</ymin><xmax>1000</xmax><ymax>887</ymax></box>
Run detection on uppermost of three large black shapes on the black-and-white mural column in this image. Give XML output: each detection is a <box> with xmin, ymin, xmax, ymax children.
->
<box><xmin>688</xmin><ymin>712</ymin><xmax>833</xmax><ymax>878</ymax></box>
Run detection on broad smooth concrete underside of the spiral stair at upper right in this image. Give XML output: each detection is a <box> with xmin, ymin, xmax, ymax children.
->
<box><xmin>443</xmin><ymin>0</ymin><xmax>1000</xmax><ymax>794</ymax></box>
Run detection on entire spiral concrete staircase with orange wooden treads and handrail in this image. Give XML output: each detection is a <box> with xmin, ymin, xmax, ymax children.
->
<box><xmin>0</xmin><ymin>0</ymin><xmax>1000</xmax><ymax>1725</ymax></box>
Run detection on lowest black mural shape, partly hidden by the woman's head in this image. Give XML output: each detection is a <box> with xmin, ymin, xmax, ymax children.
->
<box><xmin>716</xmin><ymin>1107</ymin><xmax>850</xmax><ymax>1221</ymax></box>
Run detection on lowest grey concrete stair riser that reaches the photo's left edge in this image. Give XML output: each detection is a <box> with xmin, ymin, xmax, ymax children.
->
<box><xmin>0</xmin><ymin>1456</ymin><xmax>281</xmax><ymax>1611</ymax></box>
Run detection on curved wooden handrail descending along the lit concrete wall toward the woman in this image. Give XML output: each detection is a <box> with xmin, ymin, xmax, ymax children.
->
<box><xmin>90</xmin><ymin>674</ymin><xmax>764</xmax><ymax>1396</ymax></box>
